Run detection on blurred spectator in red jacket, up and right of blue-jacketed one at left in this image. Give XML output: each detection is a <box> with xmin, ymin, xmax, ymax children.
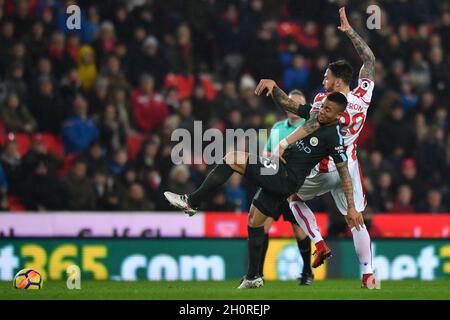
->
<box><xmin>131</xmin><ymin>74</ymin><xmax>169</xmax><ymax>133</ymax></box>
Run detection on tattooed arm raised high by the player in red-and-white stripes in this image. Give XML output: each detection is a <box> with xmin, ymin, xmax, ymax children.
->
<box><xmin>338</xmin><ymin>7</ymin><xmax>375</xmax><ymax>80</ymax></box>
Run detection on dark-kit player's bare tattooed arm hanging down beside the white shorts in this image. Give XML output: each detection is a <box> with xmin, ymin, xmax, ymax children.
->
<box><xmin>336</xmin><ymin>161</ymin><xmax>364</xmax><ymax>231</ymax></box>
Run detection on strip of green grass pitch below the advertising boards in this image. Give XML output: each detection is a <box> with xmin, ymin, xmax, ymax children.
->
<box><xmin>0</xmin><ymin>280</ymin><xmax>450</xmax><ymax>300</ymax></box>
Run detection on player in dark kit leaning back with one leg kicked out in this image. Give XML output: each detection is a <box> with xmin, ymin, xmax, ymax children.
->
<box><xmin>164</xmin><ymin>89</ymin><xmax>363</xmax><ymax>289</ymax></box>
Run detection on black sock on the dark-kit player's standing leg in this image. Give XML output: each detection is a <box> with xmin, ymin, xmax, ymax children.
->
<box><xmin>247</xmin><ymin>226</ymin><xmax>266</xmax><ymax>279</ymax></box>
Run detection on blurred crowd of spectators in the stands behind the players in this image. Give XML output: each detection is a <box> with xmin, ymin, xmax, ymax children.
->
<box><xmin>0</xmin><ymin>0</ymin><xmax>450</xmax><ymax>219</ymax></box>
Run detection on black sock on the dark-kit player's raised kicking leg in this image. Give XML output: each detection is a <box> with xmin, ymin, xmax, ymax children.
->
<box><xmin>188</xmin><ymin>163</ymin><xmax>234</xmax><ymax>208</ymax></box>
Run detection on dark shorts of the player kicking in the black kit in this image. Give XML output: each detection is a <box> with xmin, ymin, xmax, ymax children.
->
<box><xmin>244</xmin><ymin>156</ymin><xmax>297</xmax><ymax>222</ymax></box>
